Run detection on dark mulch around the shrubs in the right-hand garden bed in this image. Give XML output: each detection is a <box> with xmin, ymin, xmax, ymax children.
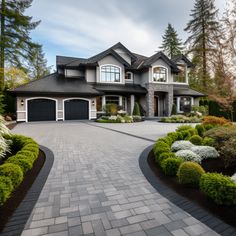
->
<box><xmin>147</xmin><ymin>151</ymin><xmax>236</xmax><ymax>228</ymax></box>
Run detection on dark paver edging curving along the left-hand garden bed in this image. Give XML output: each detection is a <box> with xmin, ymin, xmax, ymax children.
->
<box><xmin>1</xmin><ymin>145</ymin><xmax>54</xmax><ymax>236</ymax></box>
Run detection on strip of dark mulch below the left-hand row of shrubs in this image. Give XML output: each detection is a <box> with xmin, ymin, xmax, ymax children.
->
<box><xmin>0</xmin><ymin>150</ymin><xmax>45</xmax><ymax>232</ymax></box>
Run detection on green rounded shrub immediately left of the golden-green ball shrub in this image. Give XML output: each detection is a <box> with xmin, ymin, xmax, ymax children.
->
<box><xmin>161</xmin><ymin>157</ymin><xmax>183</xmax><ymax>176</ymax></box>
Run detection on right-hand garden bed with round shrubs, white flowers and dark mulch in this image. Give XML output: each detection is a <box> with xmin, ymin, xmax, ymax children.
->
<box><xmin>148</xmin><ymin>117</ymin><xmax>236</xmax><ymax>227</ymax></box>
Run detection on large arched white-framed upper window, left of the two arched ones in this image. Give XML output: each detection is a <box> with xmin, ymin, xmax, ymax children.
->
<box><xmin>101</xmin><ymin>65</ymin><xmax>121</xmax><ymax>83</ymax></box>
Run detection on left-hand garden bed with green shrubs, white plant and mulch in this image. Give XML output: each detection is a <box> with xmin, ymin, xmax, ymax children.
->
<box><xmin>0</xmin><ymin>117</ymin><xmax>45</xmax><ymax>232</ymax></box>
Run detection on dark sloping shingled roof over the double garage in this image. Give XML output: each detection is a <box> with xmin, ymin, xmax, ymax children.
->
<box><xmin>9</xmin><ymin>73</ymin><xmax>101</xmax><ymax>96</ymax></box>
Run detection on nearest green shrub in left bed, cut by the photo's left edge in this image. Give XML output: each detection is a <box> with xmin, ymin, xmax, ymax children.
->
<box><xmin>0</xmin><ymin>176</ymin><xmax>13</xmax><ymax>205</ymax></box>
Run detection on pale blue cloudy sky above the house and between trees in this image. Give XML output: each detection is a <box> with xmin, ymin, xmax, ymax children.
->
<box><xmin>26</xmin><ymin>0</ymin><xmax>227</xmax><ymax>69</ymax></box>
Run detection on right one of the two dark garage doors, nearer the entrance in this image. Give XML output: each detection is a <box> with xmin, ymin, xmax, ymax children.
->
<box><xmin>64</xmin><ymin>99</ymin><xmax>89</xmax><ymax>120</ymax></box>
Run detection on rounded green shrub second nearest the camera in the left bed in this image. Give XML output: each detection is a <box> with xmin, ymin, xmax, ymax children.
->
<box><xmin>0</xmin><ymin>163</ymin><xmax>23</xmax><ymax>188</ymax></box>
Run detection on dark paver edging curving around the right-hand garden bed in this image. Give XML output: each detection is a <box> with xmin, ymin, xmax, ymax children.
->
<box><xmin>139</xmin><ymin>145</ymin><xmax>236</xmax><ymax>236</ymax></box>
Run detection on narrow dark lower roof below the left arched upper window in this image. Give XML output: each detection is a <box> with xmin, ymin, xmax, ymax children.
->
<box><xmin>94</xmin><ymin>84</ymin><xmax>147</xmax><ymax>94</ymax></box>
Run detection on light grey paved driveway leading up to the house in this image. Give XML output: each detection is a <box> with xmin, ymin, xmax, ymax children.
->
<box><xmin>10</xmin><ymin>121</ymin><xmax>217</xmax><ymax>236</ymax></box>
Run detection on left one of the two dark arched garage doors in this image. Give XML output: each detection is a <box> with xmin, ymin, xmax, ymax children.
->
<box><xmin>28</xmin><ymin>99</ymin><xmax>56</xmax><ymax>121</ymax></box>
